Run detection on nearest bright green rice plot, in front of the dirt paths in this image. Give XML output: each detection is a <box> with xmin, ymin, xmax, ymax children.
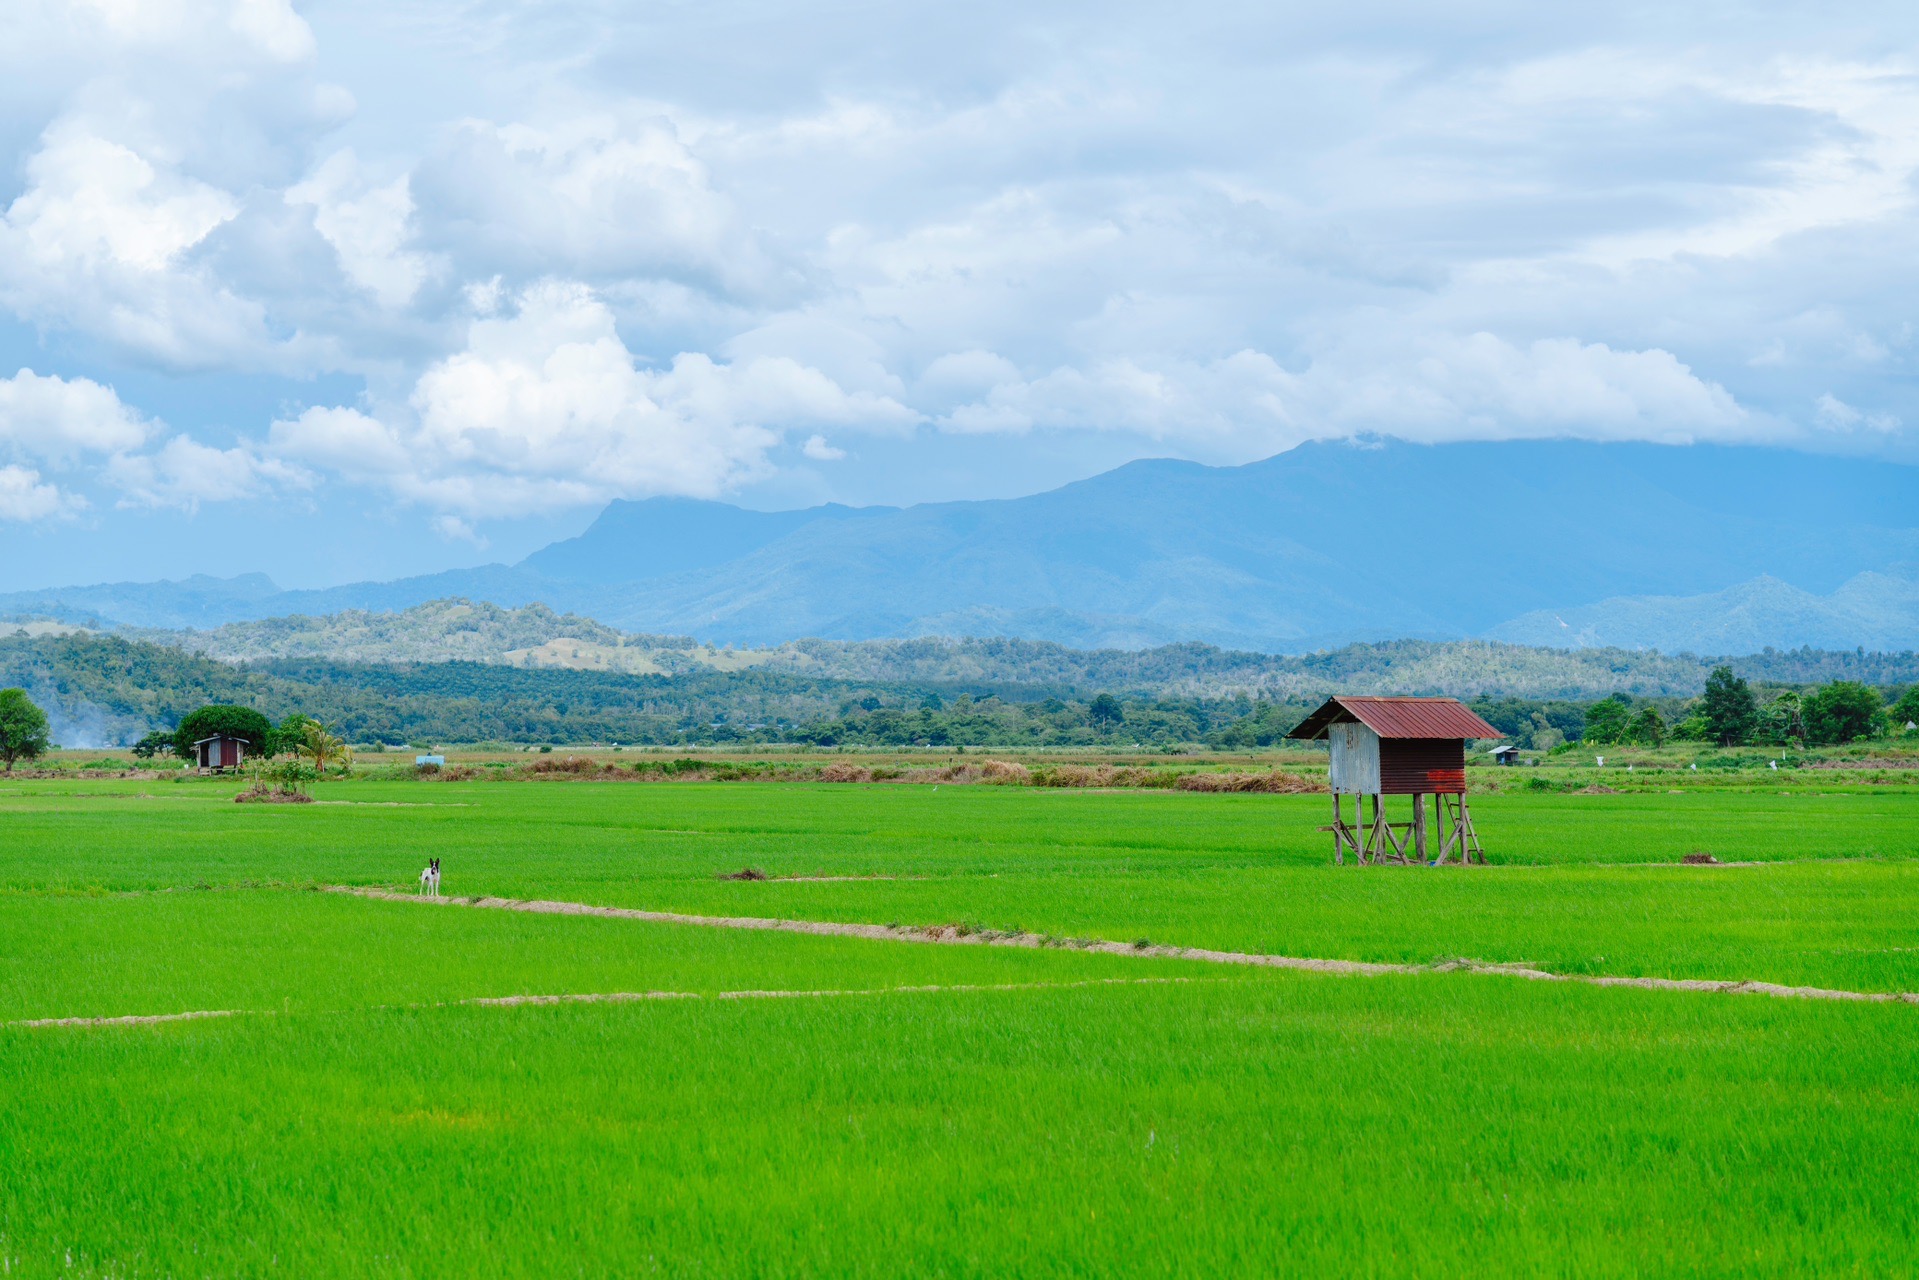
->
<box><xmin>0</xmin><ymin>974</ymin><xmax>1919</xmax><ymax>1278</ymax></box>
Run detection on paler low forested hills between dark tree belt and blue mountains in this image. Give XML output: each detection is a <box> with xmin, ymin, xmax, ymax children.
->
<box><xmin>59</xmin><ymin>599</ymin><xmax>1913</xmax><ymax>699</ymax></box>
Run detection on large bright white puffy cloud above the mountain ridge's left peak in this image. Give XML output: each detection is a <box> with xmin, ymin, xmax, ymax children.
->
<box><xmin>271</xmin><ymin>280</ymin><xmax>913</xmax><ymax>516</ymax></box>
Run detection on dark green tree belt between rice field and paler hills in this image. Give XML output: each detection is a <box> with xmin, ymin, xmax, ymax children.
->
<box><xmin>0</xmin><ymin>635</ymin><xmax>1919</xmax><ymax>754</ymax></box>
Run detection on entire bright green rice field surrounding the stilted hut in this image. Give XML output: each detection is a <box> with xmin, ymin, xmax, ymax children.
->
<box><xmin>0</xmin><ymin>779</ymin><xmax>1919</xmax><ymax>1276</ymax></box>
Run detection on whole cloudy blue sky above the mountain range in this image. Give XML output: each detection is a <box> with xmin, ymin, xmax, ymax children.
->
<box><xmin>0</xmin><ymin>0</ymin><xmax>1919</xmax><ymax>589</ymax></box>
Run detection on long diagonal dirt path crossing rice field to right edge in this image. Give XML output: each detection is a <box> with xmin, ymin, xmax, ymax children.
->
<box><xmin>324</xmin><ymin>885</ymin><xmax>1919</xmax><ymax>1004</ymax></box>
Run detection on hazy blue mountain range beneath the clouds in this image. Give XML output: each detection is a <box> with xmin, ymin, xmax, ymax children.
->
<box><xmin>11</xmin><ymin>441</ymin><xmax>1919</xmax><ymax>652</ymax></box>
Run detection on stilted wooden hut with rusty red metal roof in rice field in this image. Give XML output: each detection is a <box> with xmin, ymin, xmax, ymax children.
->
<box><xmin>1288</xmin><ymin>697</ymin><xmax>1499</xmax><ymax>865</ymax></box>
